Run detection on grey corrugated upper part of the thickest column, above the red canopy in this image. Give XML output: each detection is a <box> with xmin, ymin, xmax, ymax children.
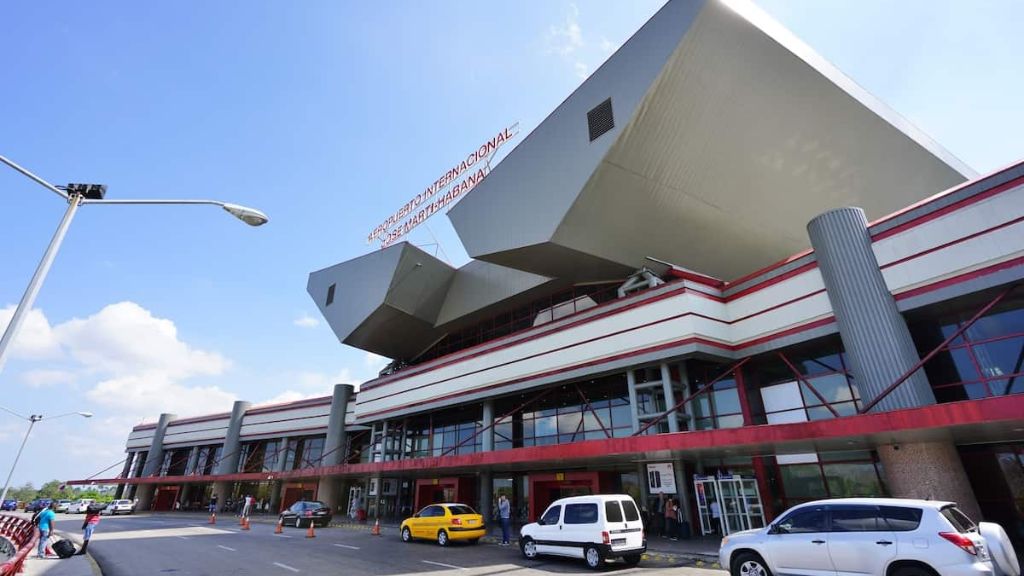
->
<box><xmin>807</xmin><ymin>208</ymin><xmax>935</xmax><ymax>412</ymax></box>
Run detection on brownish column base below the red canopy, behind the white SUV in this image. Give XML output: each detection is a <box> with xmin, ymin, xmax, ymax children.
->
<box><xmin>878</xmin><ymin>441</ymin><xmax>981</xmax><ymax>522</ymax></box>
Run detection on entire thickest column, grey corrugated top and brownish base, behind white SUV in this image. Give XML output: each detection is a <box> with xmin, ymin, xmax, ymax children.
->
<box><xmin>807</xmin><ymin>208</ymin><xmax>980</xmax><ymax>518</ymax></box>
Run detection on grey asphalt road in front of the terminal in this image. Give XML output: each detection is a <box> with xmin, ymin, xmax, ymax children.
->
<box><xmin>44</xmin><ymin>515</ymin><xmax>725</xmax><ymax>576</ymax></box>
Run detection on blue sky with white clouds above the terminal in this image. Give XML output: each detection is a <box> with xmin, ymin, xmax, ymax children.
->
<box><xmin>0</xmin><ymin>0</ymin><xmax>1024</xmax><ymax>484</ymax></box>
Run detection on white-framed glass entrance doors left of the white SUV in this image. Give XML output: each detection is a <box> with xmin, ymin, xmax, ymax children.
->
<box><xmin>693</xmin><ymin>475</ymin><xmax>765</xmax><ymax>536</ymax></box>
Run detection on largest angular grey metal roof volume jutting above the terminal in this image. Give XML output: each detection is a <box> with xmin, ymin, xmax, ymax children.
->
<box><xmin>450</xmin><ymin>0</ymin><xmax>972</xmax><ymax>281</ymax></box>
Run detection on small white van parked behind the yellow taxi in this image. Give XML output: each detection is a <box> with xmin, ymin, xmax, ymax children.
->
<box><xmin>519</xmin><ymin>494</ymin><xmax>647</xmax><ymax>569</ymax></box>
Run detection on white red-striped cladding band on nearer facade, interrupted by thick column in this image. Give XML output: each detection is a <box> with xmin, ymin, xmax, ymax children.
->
<box><xmin>356</xmin><ymin>187</ymin><xmax>1024</xmax><ymax>421</ymax></box>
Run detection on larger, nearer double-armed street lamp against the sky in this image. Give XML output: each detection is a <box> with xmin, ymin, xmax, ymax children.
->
<box><xmin>0</xmin><ymin>156</ymin><xmax>269</xmax><ymax>372</ymax></box>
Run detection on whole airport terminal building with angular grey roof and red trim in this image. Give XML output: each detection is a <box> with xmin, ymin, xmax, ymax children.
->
<box><xmin>79</xmin><ymin>0</ymin><xmax>1024</xmax><ymax>545</ymax></box>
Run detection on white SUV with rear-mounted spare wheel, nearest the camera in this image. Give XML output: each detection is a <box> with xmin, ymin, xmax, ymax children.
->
<box><xmin>719</xmin><ymin>498</ymin><xmax>1020</xmax><ymax>576</ymax></box>
